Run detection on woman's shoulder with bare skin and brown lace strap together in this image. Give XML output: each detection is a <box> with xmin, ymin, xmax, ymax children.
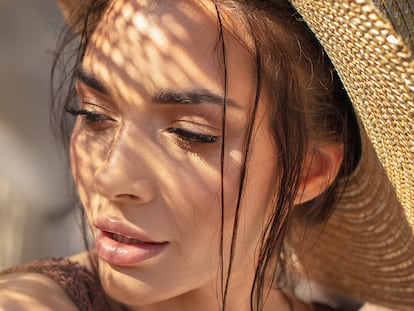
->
<box><xmin>0</xmin><ymin>253</ymin><xmax>94</xmax><ymax>311</ymax></box>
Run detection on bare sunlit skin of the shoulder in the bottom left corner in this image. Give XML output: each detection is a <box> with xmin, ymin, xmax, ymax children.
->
<box><xmin>0</xmin><ymin>272</ymin><xmax>78</xmax><ymax>311</ymax></box>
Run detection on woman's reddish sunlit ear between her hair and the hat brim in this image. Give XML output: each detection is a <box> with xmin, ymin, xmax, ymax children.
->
<box><xmin>295</xmin><ymin>143</ymin><xmax>344</xmax><ymax>204</ymax></box>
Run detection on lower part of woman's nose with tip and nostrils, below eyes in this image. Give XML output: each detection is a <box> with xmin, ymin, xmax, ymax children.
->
<box><xmin>93</xmin><ymin>136</ymin><xmax>155</xmax><ymax>204</ymax></box>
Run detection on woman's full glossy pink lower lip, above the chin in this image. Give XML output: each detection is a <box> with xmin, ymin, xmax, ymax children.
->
<box><xmin>95</xmin><ymin>230</ymin><xmax>168</xmax><ymax>266</ymax></box>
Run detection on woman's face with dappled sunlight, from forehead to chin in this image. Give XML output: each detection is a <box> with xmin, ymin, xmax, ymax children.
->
<box><xmin>71</xmin><ymin>0</ymin><xmax>276</xmax><ymax>310</ymax></box>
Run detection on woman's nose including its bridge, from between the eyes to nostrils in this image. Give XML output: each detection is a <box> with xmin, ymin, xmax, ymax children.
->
<box><xmin>93</xmin><ymin>127</ymin><xmax>155</xmax><ymax>203</ymax></box>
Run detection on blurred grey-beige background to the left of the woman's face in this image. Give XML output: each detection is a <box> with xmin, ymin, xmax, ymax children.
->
<box><xmin>0</xmin><ymin>0</ymin><xmax>83</xmax><ymax>270</ymax></box>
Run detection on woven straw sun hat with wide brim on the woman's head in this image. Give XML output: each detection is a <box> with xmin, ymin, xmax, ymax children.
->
<box><xmin>59</xmin><ymin>0</ymin><xmax>414</xmax><ymax>310</ymax></box>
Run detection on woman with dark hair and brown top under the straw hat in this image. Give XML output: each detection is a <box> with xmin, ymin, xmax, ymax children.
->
<box><xmin>0</xmin><ymin>0</ymin><xmax>413</xmax><ymax>310</ymax></box>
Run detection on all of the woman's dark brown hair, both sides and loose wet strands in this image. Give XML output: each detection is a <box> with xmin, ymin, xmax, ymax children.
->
<box><xmin>52</xmin><ymin>0</ymin><xmax>359</xmax><ymax>310</ymax></box>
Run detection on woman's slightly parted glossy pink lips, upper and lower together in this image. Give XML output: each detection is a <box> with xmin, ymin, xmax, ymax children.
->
<box><xmin>94</xmin><ymin>218</ymin><xmax>169</xmax><ymax>266</ymax></box>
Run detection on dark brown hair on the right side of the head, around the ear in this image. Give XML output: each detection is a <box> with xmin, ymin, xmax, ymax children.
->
<box><xmin>216</xmin><ymin>0</ymin><xmax>359</xmax><ymax>310</ymax></box>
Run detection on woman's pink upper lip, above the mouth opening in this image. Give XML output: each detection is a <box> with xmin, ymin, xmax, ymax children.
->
<box><xmin>93</xmin><ymin>217</ymin><xmax>166</xmax><ymax>244</ymax></box>
